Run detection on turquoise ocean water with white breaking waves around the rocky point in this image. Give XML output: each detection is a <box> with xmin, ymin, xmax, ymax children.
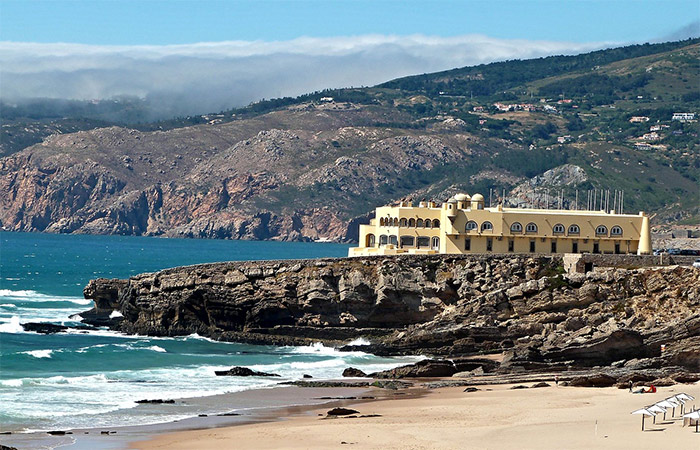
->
<box><xmin>0</xmin><ymin>232</ymin><xmax>414</xmax><ymax>432</ymax></box>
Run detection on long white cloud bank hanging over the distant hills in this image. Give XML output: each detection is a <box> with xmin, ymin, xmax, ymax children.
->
<box><xmin>0</xmin><ymin>35</ymin><xmax>607</xmax><ymax>115</ymax></box>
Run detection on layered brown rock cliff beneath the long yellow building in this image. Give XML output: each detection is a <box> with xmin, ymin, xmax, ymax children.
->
<box><xmin>83</xmin><ymin>255</ymin><xmax>700</xmax><ymax>370</ymax></box>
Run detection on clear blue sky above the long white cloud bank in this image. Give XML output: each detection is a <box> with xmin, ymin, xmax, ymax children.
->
<box><xmin>0</xmin><ymin>0</ymin><xmax>700</xmax><ymax>45</ymax></box>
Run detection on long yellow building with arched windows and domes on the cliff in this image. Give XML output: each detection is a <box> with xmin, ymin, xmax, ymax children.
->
<box><xmin>349</xmin><ymin>194</ymin><xmax>651</xmax><ymax>256</ymax></box>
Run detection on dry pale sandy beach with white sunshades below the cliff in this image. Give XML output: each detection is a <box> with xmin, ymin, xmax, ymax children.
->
<box><xmin>131</xmin><ymin>383</ymin><xmax>700</xmax><ymax>450</ymax></box>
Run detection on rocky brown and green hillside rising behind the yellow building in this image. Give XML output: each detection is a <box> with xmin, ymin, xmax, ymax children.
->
<box><xmin>0</xmin><ymin>40</ymin><xmax>700</xmax><ymax>240</ymax></box>
